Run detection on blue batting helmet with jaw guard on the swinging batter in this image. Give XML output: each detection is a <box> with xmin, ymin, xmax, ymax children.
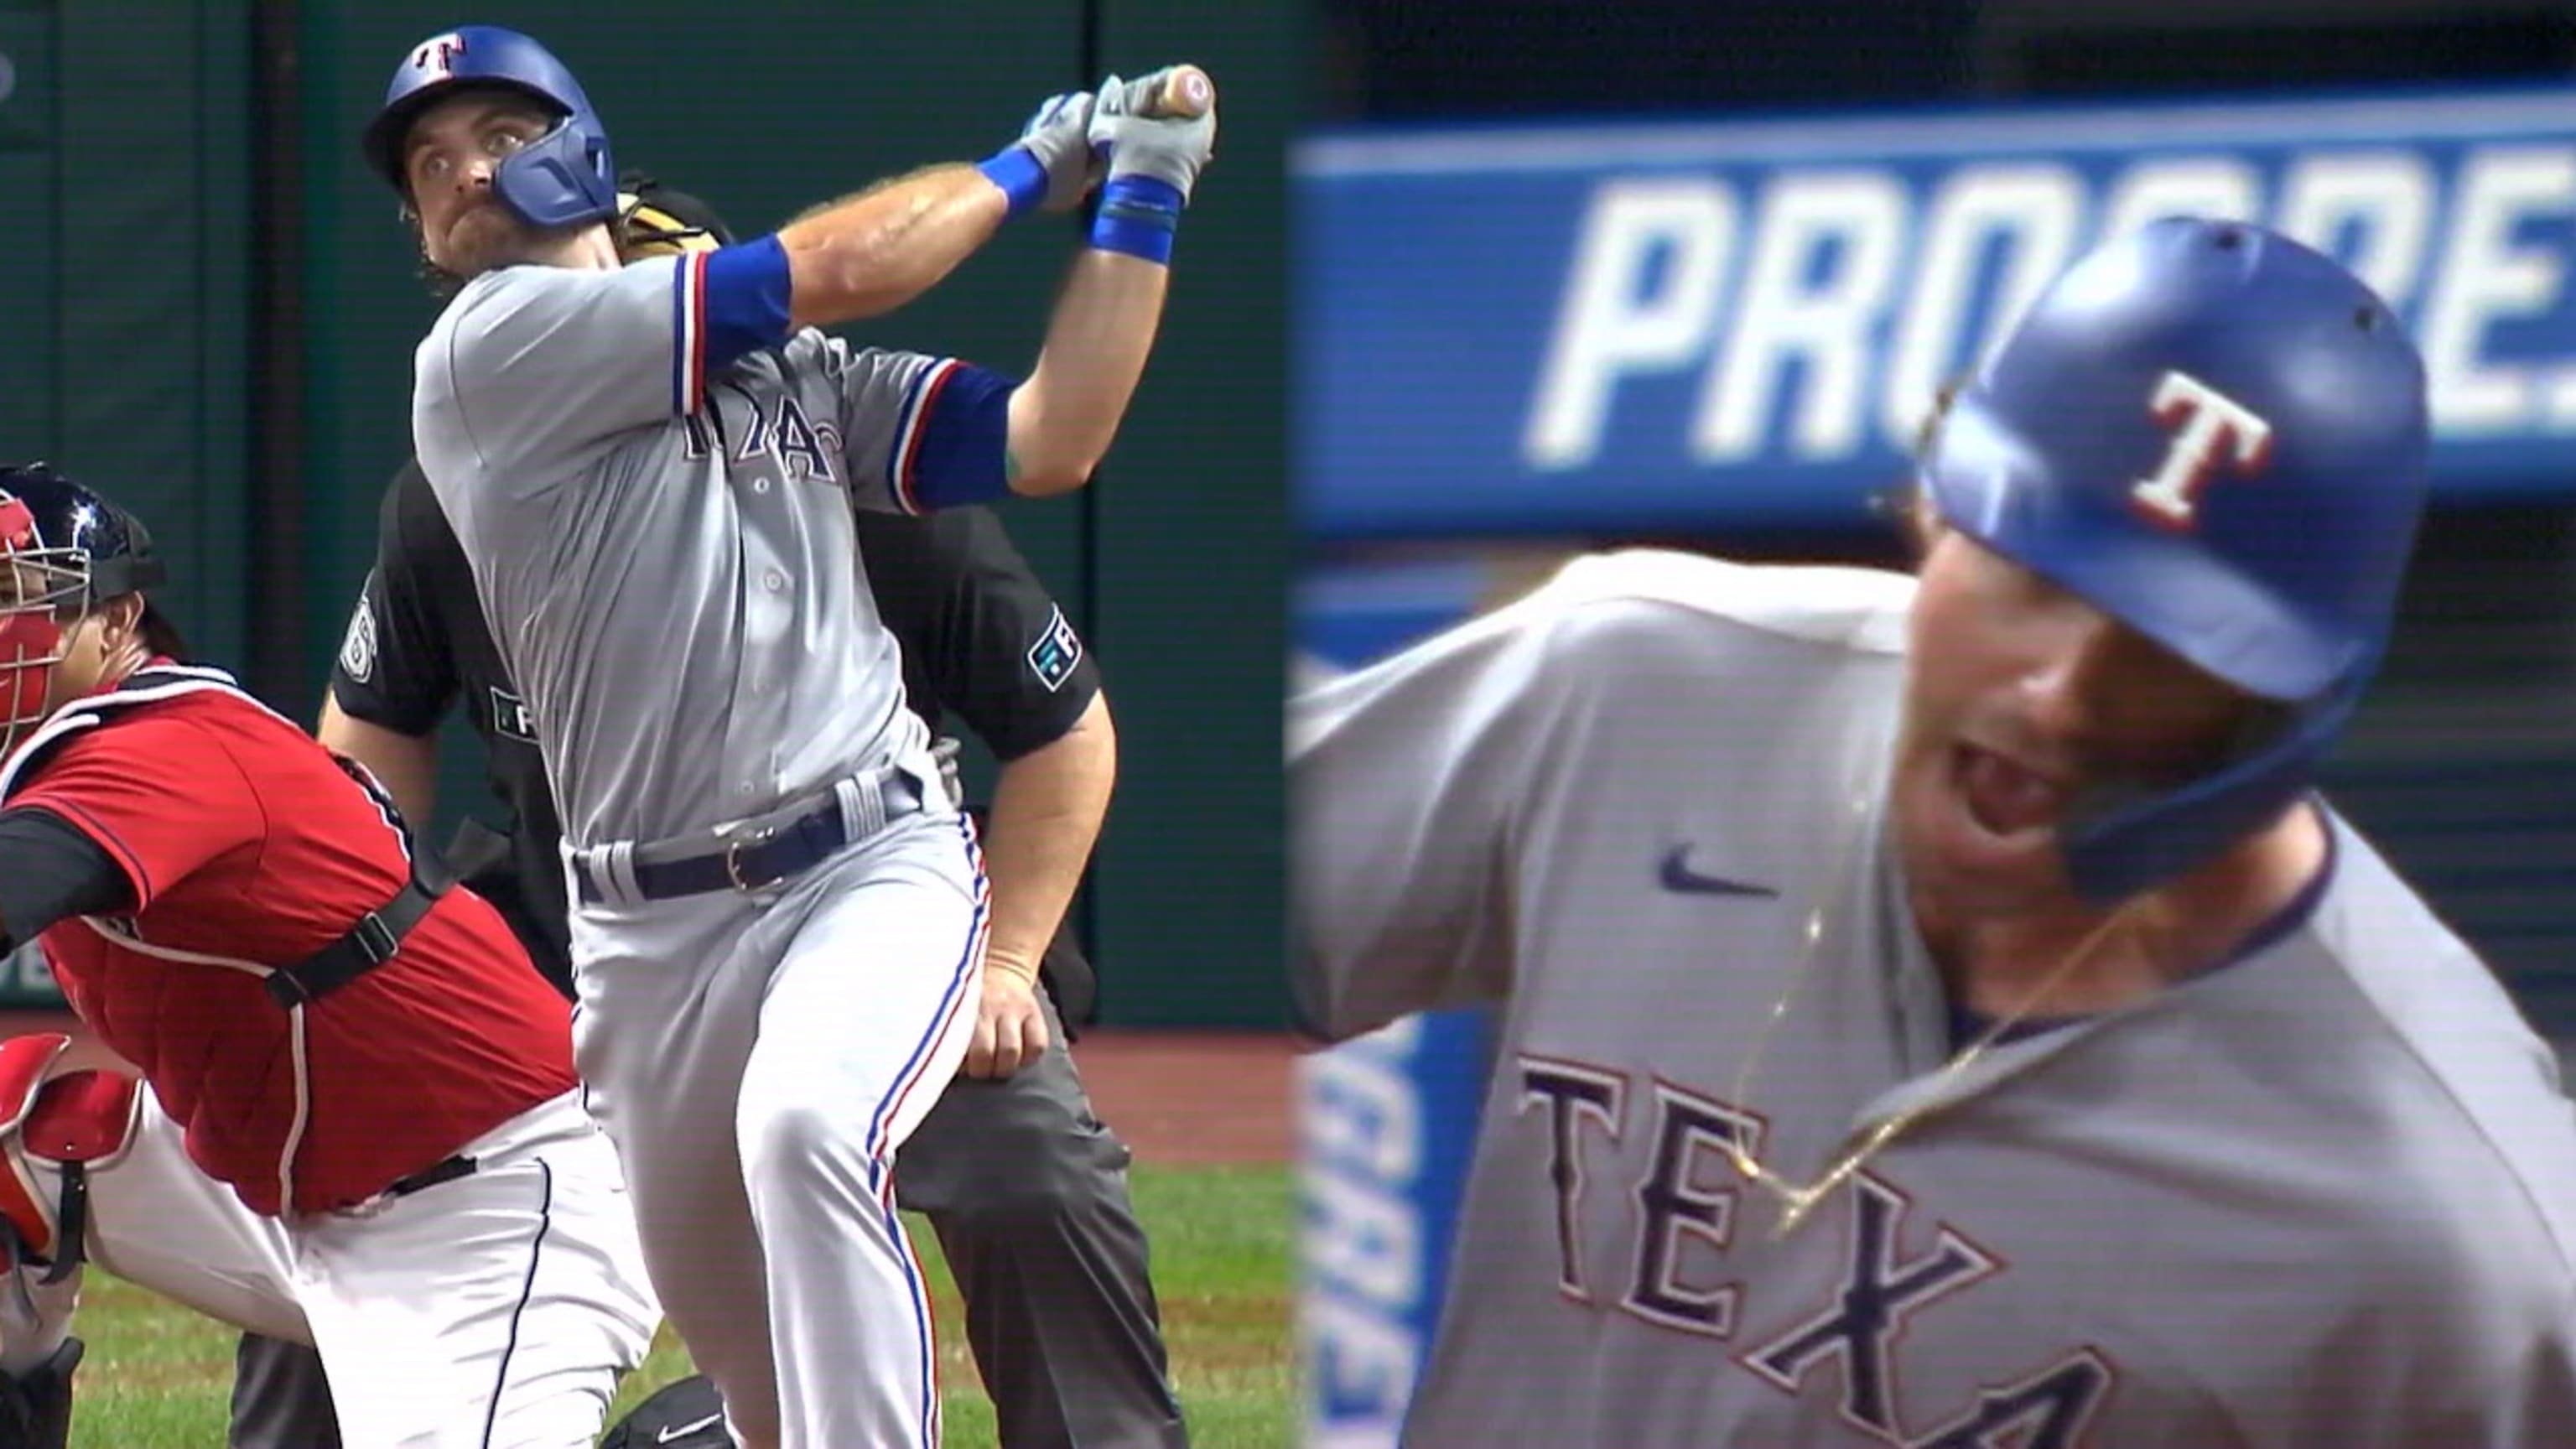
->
<box><xmin>361</xmin><ymin>26</ymin><xmax>618</xmax><ymax>227</ymax></box>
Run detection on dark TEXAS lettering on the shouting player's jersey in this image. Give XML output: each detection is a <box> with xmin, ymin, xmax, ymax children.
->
<box><xmin>1512</xmin><ymin>1052</ymin><xmax>2115</xmax><ymax>1449</ymax></box>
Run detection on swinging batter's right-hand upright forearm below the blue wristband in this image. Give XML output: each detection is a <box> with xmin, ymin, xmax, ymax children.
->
<box><xmin>1010</xmin><ymin>247</ymin><xmax>1172</xmax><ymax>497</ymax></box>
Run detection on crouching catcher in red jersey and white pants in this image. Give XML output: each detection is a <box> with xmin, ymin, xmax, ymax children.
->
<box><xmin>0</xmin><ymin>467</ymin><xmax>657</xmax><ymax>1449</ymax></box>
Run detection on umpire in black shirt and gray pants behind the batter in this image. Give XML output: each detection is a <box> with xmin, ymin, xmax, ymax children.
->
<box><xmin>231</xmin><ymin>178</ymin><xmax>1187</xmax><ymax>1449</ymax></box>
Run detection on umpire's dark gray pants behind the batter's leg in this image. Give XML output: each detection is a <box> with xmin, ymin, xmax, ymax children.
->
<box><xmin>231</xmin><ymin>993</ymin><xmax>1190</xmax><ymax>1449</ymax></box>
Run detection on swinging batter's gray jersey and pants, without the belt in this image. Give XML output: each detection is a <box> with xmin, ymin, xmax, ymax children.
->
<box><xmin>413</xmin><ymin>237</ymin><xmax>1010</xmax><ymax>1449</ymax></box>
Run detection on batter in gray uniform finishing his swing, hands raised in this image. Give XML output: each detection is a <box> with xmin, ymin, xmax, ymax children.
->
<box><xmin>366</xmin><ymin>26</ymin><xmax>1216</xmax><ymax>1449</ymax></box>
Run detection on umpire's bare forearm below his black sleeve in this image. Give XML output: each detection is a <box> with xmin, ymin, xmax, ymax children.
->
<box><xmin>984</xmin><ymin>699</ymin><xmax>1118</xmax><ymax>979</ymax></box>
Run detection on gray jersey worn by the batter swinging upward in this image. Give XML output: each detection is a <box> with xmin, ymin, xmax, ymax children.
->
<box><xmin>413</xmin><ymin>252</ymin><xmax>1007</xmax><ymax>846</ymax></box>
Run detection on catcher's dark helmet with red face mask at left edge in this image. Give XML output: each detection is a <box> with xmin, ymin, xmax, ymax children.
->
<box><xmin>0</xmin><ymin>461</ymin><xmax>163</xmax><ymax>753</ymax></box>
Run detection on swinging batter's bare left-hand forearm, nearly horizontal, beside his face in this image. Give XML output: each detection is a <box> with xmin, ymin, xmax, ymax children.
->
<box><xmin>778</xmin><ymin>165</ymin><xmax>1010</xmax><ymax>327</ymax></box>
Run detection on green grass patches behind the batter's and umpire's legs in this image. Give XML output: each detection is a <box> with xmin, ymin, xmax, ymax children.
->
<box><xmin>72</xmin><ymin>1168</ymin><xmax>1298</xmax><ymax>1449</ymax></box>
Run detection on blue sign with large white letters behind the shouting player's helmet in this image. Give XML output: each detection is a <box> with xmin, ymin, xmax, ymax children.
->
<box><xmin>1291</xmin><ymin>91</ymin><xmax>2576</xmax><ymax>539</ymax></box>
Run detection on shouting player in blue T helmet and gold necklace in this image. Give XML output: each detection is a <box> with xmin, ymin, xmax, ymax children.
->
<box><xmin>1288</xmin><ymin>219</ymin><xmax>2576</xmax><ymax>1449</ymax></box>
